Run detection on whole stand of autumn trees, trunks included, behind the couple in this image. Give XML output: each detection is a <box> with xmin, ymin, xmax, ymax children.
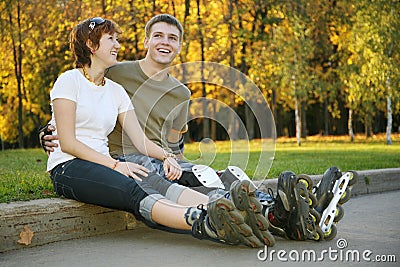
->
<box><xmin>0</xmin><ymin>0</ymin><xmax>400</xmax><ymax>147</ymax></box>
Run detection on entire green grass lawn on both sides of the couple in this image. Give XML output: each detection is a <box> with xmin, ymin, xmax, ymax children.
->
<box><xmin>0</xmin><ymin>136</ymin><xmax>400</xmax><ymax>203</ymax></box>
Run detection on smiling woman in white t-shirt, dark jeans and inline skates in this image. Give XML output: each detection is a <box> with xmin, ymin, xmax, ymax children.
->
<box><xmin>47</xmin><ymin>17</ymin><xmax>271</xmax><ymax>247</ymax></box>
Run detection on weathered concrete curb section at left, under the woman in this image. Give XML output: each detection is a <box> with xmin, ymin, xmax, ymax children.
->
<box><xmin>0</xmin><ymin>198</ymin><xmax>138</xmax><ymax>252</ymax></box>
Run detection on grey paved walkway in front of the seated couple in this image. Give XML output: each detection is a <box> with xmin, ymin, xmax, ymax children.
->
<box><xmin>0</xmin><ymin>191</ymin><xmax>400</xmax><ymax>267</ymax></box>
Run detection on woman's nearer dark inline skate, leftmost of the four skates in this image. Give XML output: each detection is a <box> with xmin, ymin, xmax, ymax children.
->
<box><xmin>185</xmin><ymin>195</ymin><xmax>264</xmax><ymax>248</ymax></box>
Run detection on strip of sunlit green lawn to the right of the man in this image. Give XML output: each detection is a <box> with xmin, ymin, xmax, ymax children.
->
<box><xmin>185</xmin><ymin>139</ymin><xmax>400</xmax><ymax>179</ymax></box>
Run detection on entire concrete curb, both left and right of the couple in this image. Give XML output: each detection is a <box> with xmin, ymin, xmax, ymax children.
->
<box><xmin>0</xmin><ymin>168</ymin><xmax>400</xmax><ymax>252</ymax></box>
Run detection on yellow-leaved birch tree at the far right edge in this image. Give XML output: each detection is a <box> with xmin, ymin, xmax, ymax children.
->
<box><xmin>339</xmin><ymin>0</ymin><xmax>399</xmax><ymax>143</ymax></box>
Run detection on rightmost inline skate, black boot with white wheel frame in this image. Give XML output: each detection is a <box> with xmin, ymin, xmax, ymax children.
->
<box><xmin>314</xmin><ymin>167</ymin><xmax>358</xmax><ymax>240</ymax></box>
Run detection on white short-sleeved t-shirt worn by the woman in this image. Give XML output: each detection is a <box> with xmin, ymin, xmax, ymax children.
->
<box><xmin>47</xmin><ymin>69</ymin><xmax>133</xmax><ymax>171</ymax></box>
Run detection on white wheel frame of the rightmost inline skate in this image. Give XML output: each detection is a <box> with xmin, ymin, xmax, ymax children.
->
<box><xmin>319</xmin><ymin>172</ymin><xmax>354</xmax><ymax>233</ymax></box>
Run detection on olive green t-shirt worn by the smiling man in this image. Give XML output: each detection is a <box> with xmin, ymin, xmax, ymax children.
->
<box><xmin>104</xmin><ymin>61</ymin><xmax>191</xmax><ymax>155</ymax></box>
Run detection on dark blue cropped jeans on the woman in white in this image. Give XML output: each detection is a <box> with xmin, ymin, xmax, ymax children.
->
<box><xmin>51</xmin><ymin>159</ymin><xmax>158</xmax><ymax>220</ymax></box>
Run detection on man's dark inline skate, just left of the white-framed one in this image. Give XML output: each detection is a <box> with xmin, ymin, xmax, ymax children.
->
<box><xmin>265</xmin><ymin>171</ymin><xmax>322</xmax><ymax>241</ymax></box>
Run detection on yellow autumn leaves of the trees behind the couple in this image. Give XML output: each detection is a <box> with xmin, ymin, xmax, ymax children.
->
<box><xmin>0</xmin><ymin>0</ymin><xmax>400</xmax><ymax>147</ymax></box>
